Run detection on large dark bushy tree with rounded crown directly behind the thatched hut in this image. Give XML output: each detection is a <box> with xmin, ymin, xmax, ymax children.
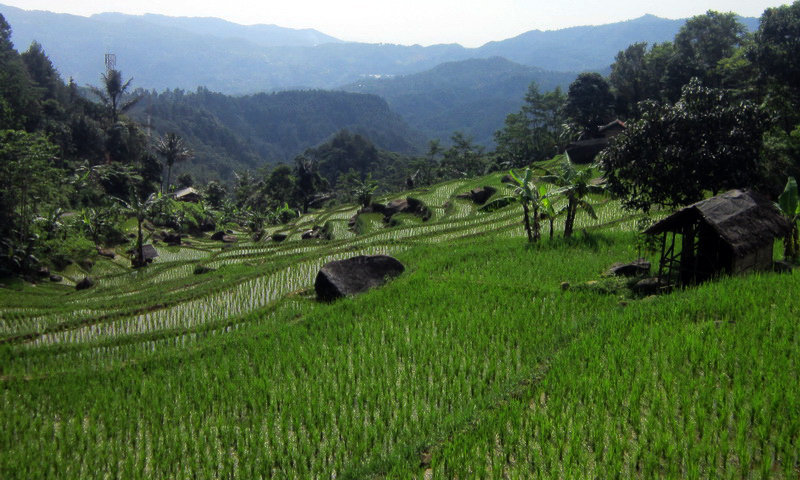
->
<box><xmin>600</xmin><ymin>79</ymin><xmax>765</xmax><ymax>211</ymax></box>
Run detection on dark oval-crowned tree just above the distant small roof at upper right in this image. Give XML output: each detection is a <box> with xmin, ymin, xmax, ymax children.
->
<box><xmin>564</xmin><ymin>73</ymin><xmax>614</xmax><ymax>137</ymax></box>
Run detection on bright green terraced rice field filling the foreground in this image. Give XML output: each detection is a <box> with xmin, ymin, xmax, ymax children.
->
<box><xmin>0</xmin><ymin>176</ymin><xmax>800</xmax><ymax>479</ymax></box>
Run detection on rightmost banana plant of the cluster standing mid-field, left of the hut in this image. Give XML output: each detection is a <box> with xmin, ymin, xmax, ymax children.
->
<box><xmin>542</xmin><ymin>156</ymin><xmax>603</xmax><ymax>238</ymax></box>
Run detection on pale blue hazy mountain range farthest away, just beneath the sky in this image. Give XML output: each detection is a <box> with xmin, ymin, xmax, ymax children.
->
<box><xmin>0</xmin><ymin>5</ymin><xmax>757</xmax><ymax>94</ymax></box>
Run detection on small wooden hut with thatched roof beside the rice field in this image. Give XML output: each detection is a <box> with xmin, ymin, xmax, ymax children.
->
<box><xmin>645</xmin><ymin>190</ymin><xmax>789</xmax><ymax>285</ymax></box>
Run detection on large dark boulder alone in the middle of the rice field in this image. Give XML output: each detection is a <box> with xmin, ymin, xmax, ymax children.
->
<box><xmin>314</xmin><ymin>255</ymin><xmax>405</xmax><ymax>301</ymax></box>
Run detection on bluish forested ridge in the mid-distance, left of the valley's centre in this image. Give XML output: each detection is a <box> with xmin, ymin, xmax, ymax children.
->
<box><xmin>129</xmin><ymin>88</ymin><xmax>425</xmax><ymax>182</ymax></box>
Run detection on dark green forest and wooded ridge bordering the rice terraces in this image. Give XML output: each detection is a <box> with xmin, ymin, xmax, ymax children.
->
<box><xmin>0</xmin><ymin>2</ymin><xmax>800</xmax><ymax>280</ymax></box>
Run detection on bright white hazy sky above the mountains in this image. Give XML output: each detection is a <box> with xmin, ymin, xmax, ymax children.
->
<box><xmin>0</xmin><ymin>0</ymin><xmax>790</xmax><ymax>47</ymax></box>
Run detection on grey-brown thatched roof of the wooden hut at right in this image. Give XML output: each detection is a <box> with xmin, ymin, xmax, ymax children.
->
<box><xmin>645</xmin><ymin>190</ymin><xmax>790</xmax><ymax>256</ymax></box>
